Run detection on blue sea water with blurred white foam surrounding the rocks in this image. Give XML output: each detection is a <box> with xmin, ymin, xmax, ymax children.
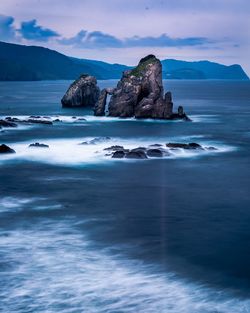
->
<box><xmin>0</xmin><ymin>81</ymin><xmax>250</xmax><ymax>313</ymax></box>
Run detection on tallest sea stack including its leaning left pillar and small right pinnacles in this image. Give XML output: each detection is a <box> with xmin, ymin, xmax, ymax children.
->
<box><xmin>94</xmin><ymin>55</ymin><xmax>188</xmax><ymax>120</ymax></box>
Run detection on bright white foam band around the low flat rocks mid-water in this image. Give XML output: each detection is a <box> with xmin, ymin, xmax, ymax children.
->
<box><xmin>0</xmin><ymin>137</ymin><xmax>235</xmax><ymax>166</ymax></box>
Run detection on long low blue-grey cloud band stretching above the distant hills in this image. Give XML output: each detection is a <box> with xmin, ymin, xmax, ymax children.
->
<box><xmin>59</xmin><ymin>30</ymin><xmax>212</xmax><ymax>49</ymax></box>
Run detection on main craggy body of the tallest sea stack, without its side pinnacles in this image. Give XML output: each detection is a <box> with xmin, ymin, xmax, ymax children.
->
<box><xmin>109</xmin><ymin>55</ymin><xmax>166</xmax><ymax>118</ymax></box>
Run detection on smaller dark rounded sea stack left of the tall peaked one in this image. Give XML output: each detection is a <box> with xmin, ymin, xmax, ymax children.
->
<box><xmin>61</xmin><ymin>75</ymin><xmax>100</xmax><ymax>107</ymax></box>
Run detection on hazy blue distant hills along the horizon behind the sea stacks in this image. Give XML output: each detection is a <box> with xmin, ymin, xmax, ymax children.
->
<box><xmin>0</xmin><ymin>42</ymin><xmax>249</xmax><ymax>81</ymax></box>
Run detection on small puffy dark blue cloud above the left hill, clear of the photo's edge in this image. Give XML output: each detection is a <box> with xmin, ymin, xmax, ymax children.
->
<box><xmin>18</xmin><ymin>19</ymin><xmax>60</xmax><ymax>41</ymax></box>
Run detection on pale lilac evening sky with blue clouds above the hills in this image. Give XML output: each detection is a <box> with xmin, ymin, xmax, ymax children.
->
<box><xmin>0</xmin><ymin>0</ymin><xmax>250</xmax><ymax>74</ymax></box>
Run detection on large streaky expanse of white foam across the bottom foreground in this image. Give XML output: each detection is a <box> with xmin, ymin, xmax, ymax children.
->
<box><xmin>0</xmin><ymin>220</ymin><xmax>250</xmax><ymax>313</ymax></box>
